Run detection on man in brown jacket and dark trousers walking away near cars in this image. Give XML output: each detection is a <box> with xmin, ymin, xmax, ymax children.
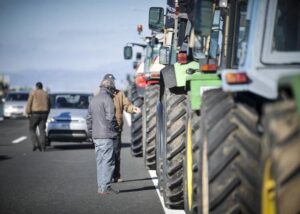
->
<box><xmin>26</xmin><ymin>82</ymin><xmax>50</xmax><ymax>151</ymax></box>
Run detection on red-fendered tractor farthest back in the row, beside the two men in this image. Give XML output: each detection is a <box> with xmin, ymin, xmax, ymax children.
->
<box><xmin>124</xmin><ymin>36</ymin><xmax>164</xmax><ymax>169</ymax></box>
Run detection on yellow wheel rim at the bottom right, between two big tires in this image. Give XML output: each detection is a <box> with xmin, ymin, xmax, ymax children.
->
<box><xmin>262</xmin><ymin>159</ymin><xmax>276</xmax><ymax>214</ymax></box>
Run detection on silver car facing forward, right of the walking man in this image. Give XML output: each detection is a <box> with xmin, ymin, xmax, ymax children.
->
<box><xmin>46</xmin><ymin>93</ymin><xmax>92</xmax><ymax>144</ymax></box>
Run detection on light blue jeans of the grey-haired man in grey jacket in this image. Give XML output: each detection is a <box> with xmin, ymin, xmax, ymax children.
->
<box><xmin>94</xmin><ymin>139</ymin><xmax>115</xmax><ymax>192</ymax></box>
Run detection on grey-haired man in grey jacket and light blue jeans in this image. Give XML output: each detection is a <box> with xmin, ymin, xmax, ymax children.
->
<box><xmin>87</xmin><ymin>79</ymin><xmax>119</xmax><ymax>194</ymax></box>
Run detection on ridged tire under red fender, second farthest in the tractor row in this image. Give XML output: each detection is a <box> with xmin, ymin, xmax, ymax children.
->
<box><xmin>143</xmin><ymin>85</ymin><xmax>159</xmax><ymax>169</ymax></box>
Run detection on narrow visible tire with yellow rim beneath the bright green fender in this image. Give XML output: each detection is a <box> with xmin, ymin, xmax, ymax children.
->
<box><xmin>184</xmin><ymin>94</ymin><xmax>201</xmax><ymax>214</ymax></box>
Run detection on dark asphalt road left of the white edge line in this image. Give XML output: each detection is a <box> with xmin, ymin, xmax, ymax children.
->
<box><xmin>0</xmin><ymin>120</ymin><xmax>165</xmax><ymax>214</ymax></box>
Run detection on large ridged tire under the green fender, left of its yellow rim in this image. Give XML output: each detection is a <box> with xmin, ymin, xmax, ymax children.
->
<box><xmin>163</xmin><ymin>89</ymin><xmax>186</xmax><ymax>209</ymax></box>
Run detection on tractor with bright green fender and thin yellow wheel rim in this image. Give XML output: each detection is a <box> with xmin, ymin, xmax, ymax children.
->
<box><xmin>149</xmin><ymin>1</ymin><xmax>221</xmax><ymax>212</ymax></box>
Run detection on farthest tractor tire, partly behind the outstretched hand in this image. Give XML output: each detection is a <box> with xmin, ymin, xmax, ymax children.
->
<box><xmin>131</xmin><ymin>86</ymin><xmax>144</xmax><ymax>157</ymax></box>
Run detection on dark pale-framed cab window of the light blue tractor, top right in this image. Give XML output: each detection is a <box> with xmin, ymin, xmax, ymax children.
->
<box><xmin>262</xmin><ymin>0</ymin><xmax>300</xmax><ymax>65</ymax></box>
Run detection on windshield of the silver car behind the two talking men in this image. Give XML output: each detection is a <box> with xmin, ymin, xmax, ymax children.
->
<box><xmin>50</xmin><ymin>94</ymin><xmax>92</xmax><ymax>109</ymax></box>
